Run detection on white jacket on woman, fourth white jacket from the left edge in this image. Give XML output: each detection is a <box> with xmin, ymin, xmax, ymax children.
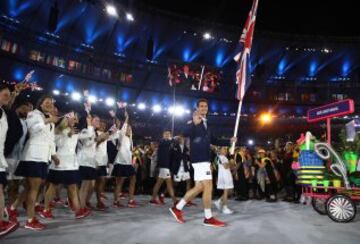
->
<box><xmin>77</xmin><ymin>126</ymin><xmax>96</xmax><ymax>168</ymax></box>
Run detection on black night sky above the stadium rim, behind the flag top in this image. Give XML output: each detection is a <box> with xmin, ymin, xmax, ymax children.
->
<box><xmin>130</xmin><ymin>0</ymin><xmax>360</xmax><ymax>36</ymax></box>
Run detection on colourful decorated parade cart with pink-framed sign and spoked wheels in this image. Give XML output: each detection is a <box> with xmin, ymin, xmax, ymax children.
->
<box><xmin>294</xmin><ymin>99</ymin><xmax>360</xmax><ymax>223</ymax></box>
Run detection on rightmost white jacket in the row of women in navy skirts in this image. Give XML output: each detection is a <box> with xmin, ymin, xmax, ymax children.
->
<box><xmin>114</xmin><ymin>123</ymin><xmax>132</xmax><ymax>165</ymax></box>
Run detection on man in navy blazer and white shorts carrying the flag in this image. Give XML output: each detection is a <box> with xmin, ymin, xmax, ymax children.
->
<box><xmin>169</xmin><ymin>99</ymin><xmax>236</xmax><ymax>227</ymax></box>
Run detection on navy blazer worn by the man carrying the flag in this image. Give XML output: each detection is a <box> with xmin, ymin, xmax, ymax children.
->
<box><xmin>183</xmin><ymin>121</ymin><xmax>218</xmax><ymax>163</ymax></box>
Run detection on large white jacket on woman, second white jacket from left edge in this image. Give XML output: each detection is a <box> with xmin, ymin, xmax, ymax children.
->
<box><xmin>21</xmin><ymin>109</ymin><xmax>56</xmax><ymax>163</ymax></box>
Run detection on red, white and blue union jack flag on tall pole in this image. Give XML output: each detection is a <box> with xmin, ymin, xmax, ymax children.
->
<box><xmin>234</xmin><ymin>0</ymin><xmax>259</xmax><ymax>101</ymax></box>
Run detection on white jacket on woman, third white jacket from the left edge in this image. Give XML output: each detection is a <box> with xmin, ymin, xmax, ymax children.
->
<box><xmin>50</xmin><ymin>128</ymin><xmax>79</xmax><ymax>171</ymax></box>
